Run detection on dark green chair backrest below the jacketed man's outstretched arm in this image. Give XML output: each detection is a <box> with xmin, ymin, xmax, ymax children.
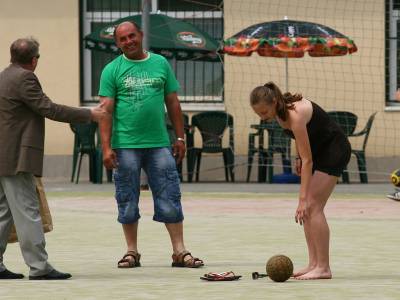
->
<box><xmin>70</xmin><ymin>122</ymin><xmax>97</xmax><ymax>153</ymax></box>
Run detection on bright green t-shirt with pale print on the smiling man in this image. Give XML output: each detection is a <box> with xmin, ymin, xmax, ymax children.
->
<box><xmin>99</xmin><ymin>52</ymin><xmax>179</xmax><ymax>149</ymax></box>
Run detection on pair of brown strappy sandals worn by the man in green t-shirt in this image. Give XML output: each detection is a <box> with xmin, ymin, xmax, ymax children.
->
<box><xmin>118</xmin><ymin>250</ymin><xmax>204</xmax><ymax>269</ymax></box>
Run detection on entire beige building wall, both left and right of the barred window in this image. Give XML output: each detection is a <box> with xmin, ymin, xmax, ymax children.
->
<box><xmin>0</xmin><ymin>0</ymin><xmax>400</xmax><ymax>166</ymax></box>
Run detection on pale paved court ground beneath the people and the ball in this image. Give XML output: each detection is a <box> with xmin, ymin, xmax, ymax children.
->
<box><xmin>0</xmin><ymin>180</ymin><xmax>400</xmax><ymax>300</ymax></box>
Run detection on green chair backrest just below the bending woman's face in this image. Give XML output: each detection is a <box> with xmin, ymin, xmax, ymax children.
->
<box><xmin>261</xmin><ymin>120</ymin><xmax>291</xmax><ymax>156</ymax></box>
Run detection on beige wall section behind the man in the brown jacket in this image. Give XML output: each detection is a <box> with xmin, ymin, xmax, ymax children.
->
<box><xmin>0</xmin><ymin>0</ymin><xmax>79</xmax><ymax>155</ymax></box>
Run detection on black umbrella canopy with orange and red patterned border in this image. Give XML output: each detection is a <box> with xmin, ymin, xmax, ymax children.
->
<box><xmin>223</xmin><ymin>20</ymin><xmax>357</xmax><ymax>57</ymax></box>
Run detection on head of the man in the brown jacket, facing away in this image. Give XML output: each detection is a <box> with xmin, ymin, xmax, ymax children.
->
<box><xmin>10</xmin><ymin>37</ymin><xmax>39</xmax><ymax>65</ymax></box>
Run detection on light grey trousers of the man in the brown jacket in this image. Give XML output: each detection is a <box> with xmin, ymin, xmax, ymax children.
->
<box><xmin>0</xmin><ymin>173</ymin><xmax>53</xmax><ymax>276</ymax></box>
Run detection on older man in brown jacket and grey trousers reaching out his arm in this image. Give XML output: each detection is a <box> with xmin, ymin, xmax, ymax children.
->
<box><xmin>0</xmin><ymin>38</ymin><xmax>104</xmax><ymax>280</ymax></box>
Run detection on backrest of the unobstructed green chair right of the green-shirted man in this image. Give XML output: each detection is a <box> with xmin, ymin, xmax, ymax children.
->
<box><xmin>192</xmin><ymin>111</ymin><xmax>234</xmax><ymax>153</ymax></box>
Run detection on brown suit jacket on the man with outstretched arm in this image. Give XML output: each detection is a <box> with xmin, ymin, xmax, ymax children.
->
<box><xmin>0</xmin><ymin>64</ymin><xmax>91</xmax><ymax>176</ymax></box>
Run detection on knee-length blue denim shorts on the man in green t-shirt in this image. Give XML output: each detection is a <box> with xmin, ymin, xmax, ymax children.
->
<box><xmin>114</xmin><ymin>147</ymin><xmax>183</xmax><ymax>224</ymax></box>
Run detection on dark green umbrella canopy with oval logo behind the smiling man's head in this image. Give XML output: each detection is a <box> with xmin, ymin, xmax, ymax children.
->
<box><xmin>84</xmin><ymin>14</ymin><xmax>219</xmax><ymax>61</ymax></box>
